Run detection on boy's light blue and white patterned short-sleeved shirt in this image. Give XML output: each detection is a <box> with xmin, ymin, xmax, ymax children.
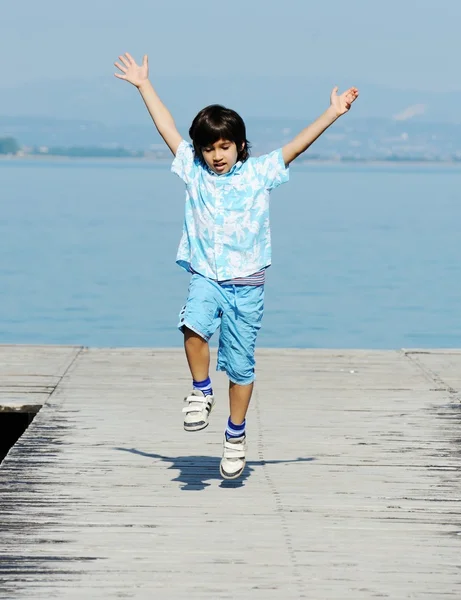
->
<box><xmin>171</xmin><ymin>140</ymin><xmax>289</xmax><ymax>281</ymax></box>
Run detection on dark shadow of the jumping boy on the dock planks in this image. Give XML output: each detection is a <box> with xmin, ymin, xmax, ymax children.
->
<box><xmin>114</xmin><ymin>448</ymin><xmax>315</xmax><ymax>491</ymax></box>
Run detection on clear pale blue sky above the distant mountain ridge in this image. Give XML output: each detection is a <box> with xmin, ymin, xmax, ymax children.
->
<box><xmin>0</xmin><ymin>0</ymin><xmax>461</xmax><ymax>91</ymax></box>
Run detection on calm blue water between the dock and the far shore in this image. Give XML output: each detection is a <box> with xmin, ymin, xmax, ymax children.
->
<box><xmin>0</xmin><ymin>161</ymin><xmax>461</xmax><ymax>348</ymax></box>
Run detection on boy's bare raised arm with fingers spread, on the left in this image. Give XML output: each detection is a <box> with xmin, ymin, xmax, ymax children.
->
<box><xmin>114</xmin><ymin>52</ymin><xmax>182</xmax><ymax>154</ymax></box>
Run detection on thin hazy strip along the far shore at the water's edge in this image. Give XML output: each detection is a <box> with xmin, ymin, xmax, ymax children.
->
<box><xmin>0</xmin><ymin>155</ymin><xmax>461</xmax><ymax>167</ymax></box>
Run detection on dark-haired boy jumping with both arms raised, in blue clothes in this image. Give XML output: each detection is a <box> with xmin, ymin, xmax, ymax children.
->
<box><xmin>115</xmin><ymin>53</ymin><xmax>358</xmax><ymax>479</ymax></box>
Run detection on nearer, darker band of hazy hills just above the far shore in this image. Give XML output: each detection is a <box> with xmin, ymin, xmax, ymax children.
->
<box><xmin>0</xmin><ymin>114</ymin><xmax>461</xmax><ymax>160</ymax></box>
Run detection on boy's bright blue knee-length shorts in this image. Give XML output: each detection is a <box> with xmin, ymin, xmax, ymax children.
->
<box><xmin>178</xmin><ymin>274</ymin><xmax>264</xmax><ymax>385</ymax></box>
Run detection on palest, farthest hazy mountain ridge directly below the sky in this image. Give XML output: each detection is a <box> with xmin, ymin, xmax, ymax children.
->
<box><xmin>0</xmin><ymin>76</ymin><xmax>461</xmax><ymax>126</ymax></box>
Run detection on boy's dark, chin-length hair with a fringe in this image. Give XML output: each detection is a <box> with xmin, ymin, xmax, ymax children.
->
<box><xmin>189</xmin><ymin>104</ymin><xmax>250</xmax><ymax>164</ymax></box>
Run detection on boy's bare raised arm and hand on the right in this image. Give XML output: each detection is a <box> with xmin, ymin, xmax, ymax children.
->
<box><xmin>282</xmin><ymin>87</ymin><xmax>359</xmax><ymax>166</ymax></box>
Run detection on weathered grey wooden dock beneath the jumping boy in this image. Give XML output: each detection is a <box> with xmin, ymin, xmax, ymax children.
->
<box><xmin>0</xmin><ymin>346</ymin><xmax>461</xmax><ymax>600</ymax></box>
